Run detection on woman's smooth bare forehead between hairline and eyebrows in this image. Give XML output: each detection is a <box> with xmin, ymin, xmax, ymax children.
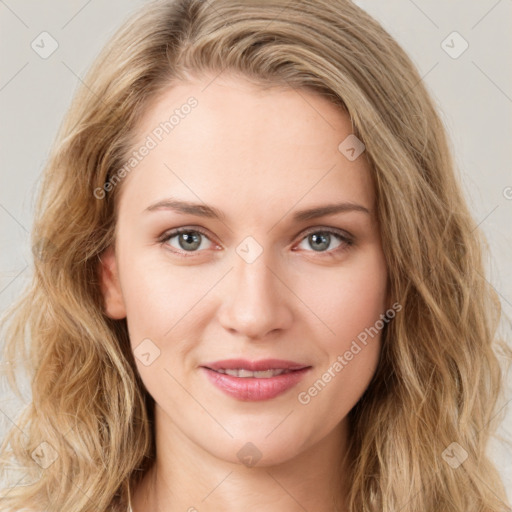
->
<box><xmin>121</xmin><ymin>76</ymin><xmax>374</xmax><ymax>218</ymax></box>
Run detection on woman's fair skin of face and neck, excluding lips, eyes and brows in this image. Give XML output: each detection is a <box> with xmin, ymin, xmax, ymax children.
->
<box><xmin>101</xmin><ymin>75</ymin><xmax>390</xmax><ymax>512</ymax></box>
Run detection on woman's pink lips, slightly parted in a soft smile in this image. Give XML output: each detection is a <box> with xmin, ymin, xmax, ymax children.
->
<box><xmin>201</xmin><ymin>359</ymin><xmax>311</xmax><ymax>401</ymax></box>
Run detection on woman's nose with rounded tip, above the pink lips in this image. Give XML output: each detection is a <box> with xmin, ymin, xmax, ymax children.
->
<box><xmin>218</xmin><ymin>251</ymin><xmax>293</xmax><ymax>340</ymax></box>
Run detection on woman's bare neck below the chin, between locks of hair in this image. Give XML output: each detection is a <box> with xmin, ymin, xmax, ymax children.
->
<box><xmin>132</xmin><ymin>406</ymin><xmax>347</xmax><ymax>512</ymax></box>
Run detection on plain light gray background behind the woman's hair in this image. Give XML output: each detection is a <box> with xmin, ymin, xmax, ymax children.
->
<box><xmin>0</xmin><ymin>0</ymin><xmax>512</xmax><ymax>500</ymax></box>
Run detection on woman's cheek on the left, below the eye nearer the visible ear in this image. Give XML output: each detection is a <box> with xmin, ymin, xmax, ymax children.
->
<box><xmin>117</xmin><ymin>248</ymin><xmax>224</xmax><ymax>384</ymax></box>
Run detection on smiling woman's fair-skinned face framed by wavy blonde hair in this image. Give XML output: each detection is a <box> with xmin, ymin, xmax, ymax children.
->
<box><xmin>102</xmin><ymin>72</ymin><xmax>389</xmax><ymax>464</ymax></box>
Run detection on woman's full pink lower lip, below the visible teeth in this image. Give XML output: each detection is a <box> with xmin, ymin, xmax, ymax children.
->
<box><xmin>201</xmin><ymin>366</ymin><xmax>311</xmax><ymax>402</ymax></box>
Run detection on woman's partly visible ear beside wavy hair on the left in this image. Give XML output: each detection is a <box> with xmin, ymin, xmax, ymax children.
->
<box><xmin>98</xmin><ymin>246</ymin><xmax>126</xmax><ymax>320</ymax></box>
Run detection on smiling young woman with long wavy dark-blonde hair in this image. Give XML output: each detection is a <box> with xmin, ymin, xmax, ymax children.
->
<box><xmin>0</xmin><ymin>0</ymin><xmax>510</xmax><ymax>512</ymax></box>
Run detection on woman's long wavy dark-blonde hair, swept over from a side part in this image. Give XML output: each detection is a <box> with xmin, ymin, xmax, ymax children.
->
<box><xmin>0</xmin><ymin>0</ymin><xmax>511</xmax><ymax>512</ymax></box>
